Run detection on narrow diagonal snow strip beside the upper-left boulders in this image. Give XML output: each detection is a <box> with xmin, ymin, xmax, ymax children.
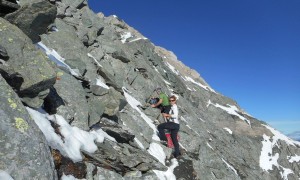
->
<box><xmin>36</xmin><ymin>42</ymin><xmax>80</xmax><ymax>76</ymax></box>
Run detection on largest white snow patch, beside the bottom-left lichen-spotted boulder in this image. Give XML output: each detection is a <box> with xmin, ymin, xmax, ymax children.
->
<box><xmin>26</xmin><ymin>107</ymin><xmax>116</xmax><ymax>162</ymax></box>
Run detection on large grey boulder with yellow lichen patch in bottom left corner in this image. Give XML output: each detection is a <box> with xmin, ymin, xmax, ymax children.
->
<box><xmin>0</xmin><ymin>75</ymin><xmax>57</xmax><ymax>180</ymax></box>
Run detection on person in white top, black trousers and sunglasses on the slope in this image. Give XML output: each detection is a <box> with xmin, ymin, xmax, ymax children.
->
<box><xmin>157</xmin><ymin>95</ymin><xmax>180</xmax><ymax>158</ymax></box>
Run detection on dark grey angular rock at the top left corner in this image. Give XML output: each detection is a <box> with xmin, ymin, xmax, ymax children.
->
<box><xmin>5</xmin><ymin>0</ymin><xmax>56</xmax><ymax>43</ymax></box>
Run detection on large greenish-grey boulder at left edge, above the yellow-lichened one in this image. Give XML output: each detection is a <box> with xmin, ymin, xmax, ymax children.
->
<box><xmin>0</xmin><ymin>18</ymin><xmax>56</xmax><ymax>108</ymax></box>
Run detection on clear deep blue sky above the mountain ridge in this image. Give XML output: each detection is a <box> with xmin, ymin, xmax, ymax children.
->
<box><xmin>89</xmin><ymin>0</ymin><xmax>300</xmax><ymax>133</ymax></box>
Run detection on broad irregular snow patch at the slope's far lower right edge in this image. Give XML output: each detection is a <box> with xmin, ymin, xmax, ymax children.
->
<box><xmin>259</xmin><ymin>124</ymin><xmax>299</xmax><ymax>180</ymax></box>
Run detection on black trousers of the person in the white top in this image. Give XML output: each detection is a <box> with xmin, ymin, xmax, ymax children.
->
<box><xmin>157</xmin><ymin>122</ymin><xmax>180</xmax><ymax>157</ymax></box>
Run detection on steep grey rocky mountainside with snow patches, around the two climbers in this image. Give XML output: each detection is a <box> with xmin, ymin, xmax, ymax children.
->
<box><xmin>0</xmin><ymin>0</ymin><xmax>300</xmax><ymax>180</ymax></box>
